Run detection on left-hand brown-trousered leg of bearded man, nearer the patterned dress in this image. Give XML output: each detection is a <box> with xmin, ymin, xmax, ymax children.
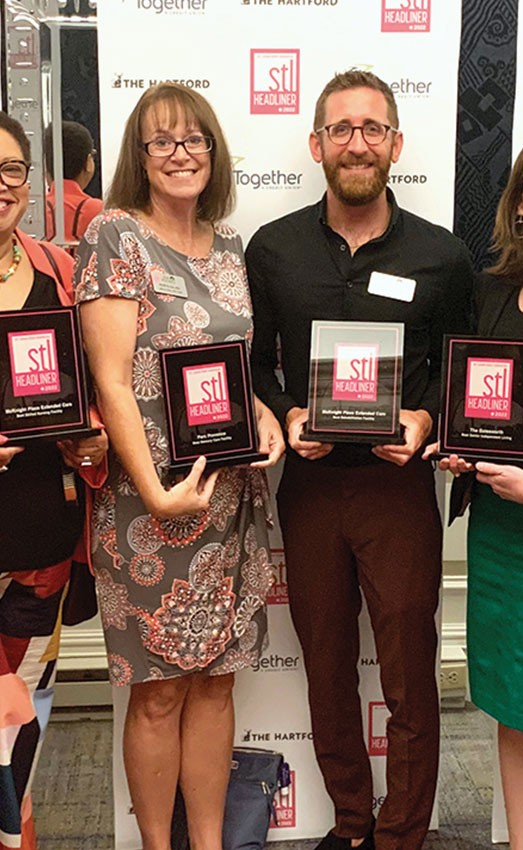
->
<box><xmin>278</xmin><ymin>454</ymin><xmax>372</xmax><ymax>838</ymax></box>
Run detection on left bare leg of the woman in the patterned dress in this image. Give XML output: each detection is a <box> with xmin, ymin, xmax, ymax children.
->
<box><xmin>124</xmin><ymin>676</ymin><xmax>191</xmax><ymax>850</ymax></box>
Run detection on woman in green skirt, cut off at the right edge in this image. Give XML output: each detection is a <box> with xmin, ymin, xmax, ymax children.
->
<box><xmin>427</xmin><ymin>151</ymin><xmax>523</xmax><ymax>850</ymax></box>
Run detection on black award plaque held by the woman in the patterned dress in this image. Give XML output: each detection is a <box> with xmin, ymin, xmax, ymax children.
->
<box><xmin>160</xmin><ymin>339</ymin><xmax>267</xmax><ymax>469</ymax></box>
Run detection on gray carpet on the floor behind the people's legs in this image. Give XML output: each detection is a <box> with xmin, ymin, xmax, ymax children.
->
<box><xmin>33</xmin><ymin>708</ymin><xmax>507</xmax><ymax>850</ymax></box>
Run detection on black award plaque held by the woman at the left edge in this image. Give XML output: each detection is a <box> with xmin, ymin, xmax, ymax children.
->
<box><xmin>0</xmin><ymin>307</ymin><xmax>97</xmax><ymax>443</ymax></box>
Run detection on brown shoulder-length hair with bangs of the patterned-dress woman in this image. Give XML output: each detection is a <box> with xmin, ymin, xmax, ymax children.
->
<box><xmin>106</xmin><ymin>83</ymin><xmax>235</xmax><ymax>223</ymax></box>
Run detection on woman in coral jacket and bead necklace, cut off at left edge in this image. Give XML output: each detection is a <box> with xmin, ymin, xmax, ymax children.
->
<box><xmin>0</xmin><ymin>112</ymin><xmax>107</xmax><ymax>850</ymax></box>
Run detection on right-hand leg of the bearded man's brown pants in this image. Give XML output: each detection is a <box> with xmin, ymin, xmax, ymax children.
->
<box><xmin>346</xmin><ymin>459</ymin><xmax>441</xmax><ymax>850</ymax></box>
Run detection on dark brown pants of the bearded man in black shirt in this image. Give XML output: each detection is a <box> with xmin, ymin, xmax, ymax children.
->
<box><xmin>278</xmin><ymin>458</ymin><xmax>441</xmax><ymax>850</ymax></box>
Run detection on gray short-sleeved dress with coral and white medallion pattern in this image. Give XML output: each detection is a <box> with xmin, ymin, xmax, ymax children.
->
<box><xmin>76</xmin><ymin>210</ymin><xmax>272</xmax><ymax>685</ymax></box>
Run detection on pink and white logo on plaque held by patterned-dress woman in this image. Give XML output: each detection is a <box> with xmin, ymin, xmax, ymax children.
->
<box><xmin>183</xmin><ymin>363</ymin><xmax>231</xmax><ymax>425</ymax></box>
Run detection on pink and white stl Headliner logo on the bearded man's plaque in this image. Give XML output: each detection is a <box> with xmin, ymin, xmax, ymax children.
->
<box><xmin>332</xmin><ymin>342</ymin><xmax>379</xmax><ymax>401</ymax></box>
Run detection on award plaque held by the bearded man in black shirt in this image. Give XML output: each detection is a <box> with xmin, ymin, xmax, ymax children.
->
<box><xmin>301</xmin><ymin>314</ymin><xmax>404</xmax><ymax>444</ymax></box>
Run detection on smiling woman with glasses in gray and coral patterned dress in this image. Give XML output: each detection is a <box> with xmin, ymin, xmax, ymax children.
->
<box><xmin>76</xmin><ymin>84</ymin><xmax>283</xmax><ymax>850</ymax></box>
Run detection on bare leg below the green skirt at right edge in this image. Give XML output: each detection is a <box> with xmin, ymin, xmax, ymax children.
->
<box><xmin>498</xmin><ymin>723</ymin><xmax>523</xmax><ymax>850</ymax></box>
